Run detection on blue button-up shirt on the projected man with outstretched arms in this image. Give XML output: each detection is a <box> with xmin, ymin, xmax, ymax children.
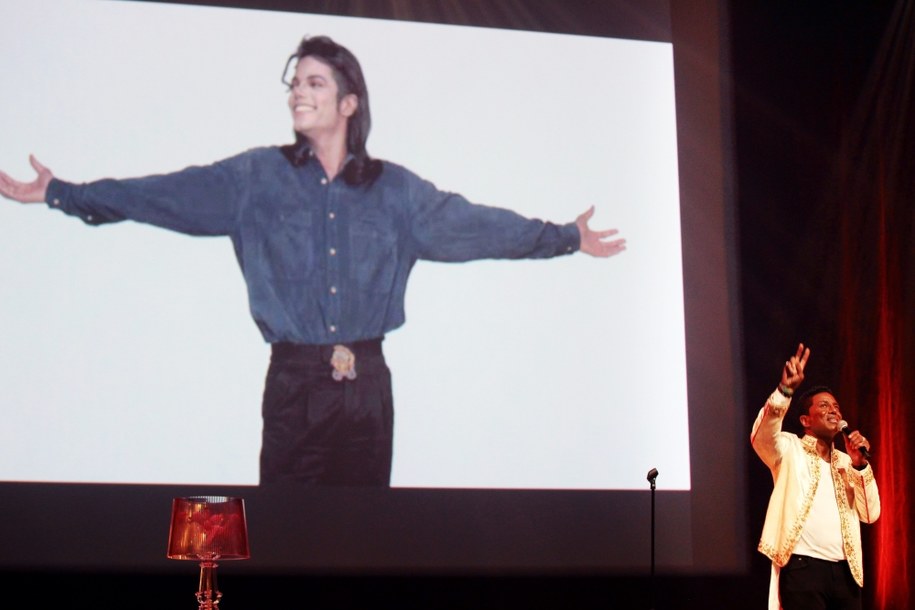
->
<box><xmin>47</xmin><ymin>147</ymin><xmax>579</xmax><ymax>344</ymax></box>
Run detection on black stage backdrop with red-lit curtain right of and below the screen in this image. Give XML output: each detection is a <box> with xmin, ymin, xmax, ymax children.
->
<box><xmin>0</xmin><ymin>1</ymin><xmax>915</xmax><ymax>610</ymax></box>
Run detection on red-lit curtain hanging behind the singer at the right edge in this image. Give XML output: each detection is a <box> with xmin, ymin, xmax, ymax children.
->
<box><xmin>836</xmin><ymin>2</ymin><xmax>915</xmax><ymax>610</ymax></box>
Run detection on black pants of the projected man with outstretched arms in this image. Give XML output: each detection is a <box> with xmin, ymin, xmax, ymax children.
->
<box><xmin>260</xmin><ymin>339</ymin><xmax>394</xmax><ymax>487</ymax></box>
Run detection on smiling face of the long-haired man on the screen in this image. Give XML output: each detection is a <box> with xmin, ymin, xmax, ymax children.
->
<box><xmin>289</xmin><ymin>56</ymin><xmax>358</xmax><ymax>146</ymax></box>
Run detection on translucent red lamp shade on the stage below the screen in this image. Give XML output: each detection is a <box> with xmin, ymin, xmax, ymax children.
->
<box><xmin>167</xmin><ymin>496</ymin><xmax>251</xmax><ymax>561</ymax></box>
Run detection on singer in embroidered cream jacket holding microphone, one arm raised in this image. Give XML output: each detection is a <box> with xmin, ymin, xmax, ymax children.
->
<box><xmin>750</xmin><ymin>343</ymin><xmax>880</xmax><ymax>610</ymax></box>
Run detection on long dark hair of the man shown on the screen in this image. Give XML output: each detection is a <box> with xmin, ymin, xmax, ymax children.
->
<box><xmin>283</xmin><ymin>36</ymin><xmax>382</xmax><ymax>185</ymax></box>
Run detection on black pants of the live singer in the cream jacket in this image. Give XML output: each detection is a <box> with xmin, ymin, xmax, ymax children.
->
<box><xmin>778</xmin><ymin>555</ymin><xmax>861</xmax><ymax>610</ymax></box>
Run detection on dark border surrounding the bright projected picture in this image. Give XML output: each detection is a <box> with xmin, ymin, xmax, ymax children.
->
<box><xmin>0</xmin><ymin>1</ymin><xmax>748</xmax><ymax>573</ymax></box>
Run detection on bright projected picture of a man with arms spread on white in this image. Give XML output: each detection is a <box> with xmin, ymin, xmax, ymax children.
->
<box><xmin>0</xmin><ymin>0</ymin><xmax>690</xmax><ymax>489</ymax></box>
